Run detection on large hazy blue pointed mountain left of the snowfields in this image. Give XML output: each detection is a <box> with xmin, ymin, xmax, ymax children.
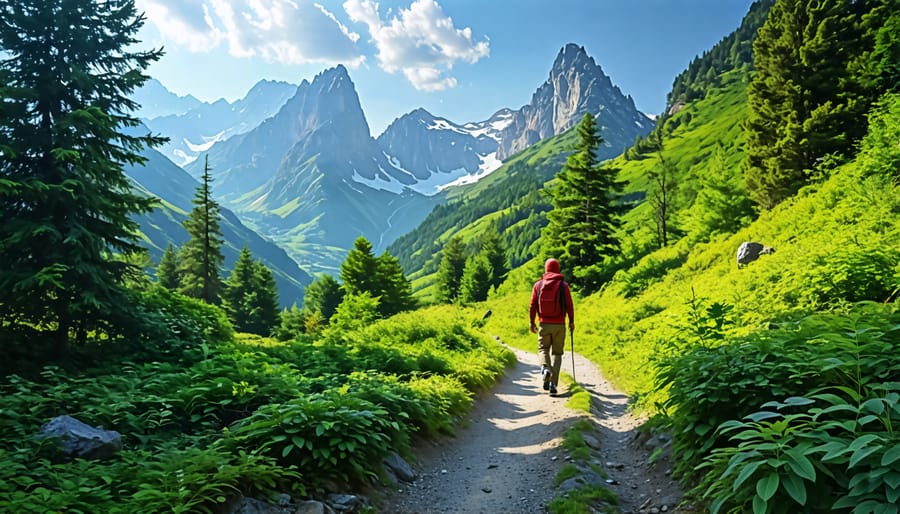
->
<box><xmin>186</xmin><ymin>66</ymin><xmax>434</xmax><ymax>272</ymax></box>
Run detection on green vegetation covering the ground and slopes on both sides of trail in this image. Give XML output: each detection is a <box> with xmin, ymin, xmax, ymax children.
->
<box><xmin>0</xmin><ymin>0</ymin><xmax>900</xmax><ymax>514</ymax></box>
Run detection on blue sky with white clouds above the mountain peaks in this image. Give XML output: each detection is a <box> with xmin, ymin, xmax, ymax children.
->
<box><xmin>137</xmin><ymin>0</ymin><xmax>752</xmax><ymax>136</ymax></box>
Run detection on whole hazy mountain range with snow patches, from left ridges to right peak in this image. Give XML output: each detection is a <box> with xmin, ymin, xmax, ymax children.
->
<box><xmin>144</xmin><ymin>45</ymin><xmax>653</xmax><ymax>272</ymax></box>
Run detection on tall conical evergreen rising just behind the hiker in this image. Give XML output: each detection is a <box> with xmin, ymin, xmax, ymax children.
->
<box><xmin>542</xmin><ymin>113</ymin><xmax>623</xmax><ymax>292</ymax></box>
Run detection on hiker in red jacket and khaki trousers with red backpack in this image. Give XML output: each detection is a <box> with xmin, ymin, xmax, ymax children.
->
<box><xmin>529</xmin><ymin>258</ymin><xmax>575</xmax><ymax>394</ymax></box>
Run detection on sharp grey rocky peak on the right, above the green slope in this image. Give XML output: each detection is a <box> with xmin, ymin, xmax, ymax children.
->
<box><xmin>497</xmin><ymin>43</ymin><xmax>654</xmax><ymax>160</ymax></box>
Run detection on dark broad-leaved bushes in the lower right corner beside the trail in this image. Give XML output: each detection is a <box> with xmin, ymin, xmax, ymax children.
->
<box><xmin>658</xmin><ymin>303</ymin><xmax>900</xmax><ymax>513</ymax></box>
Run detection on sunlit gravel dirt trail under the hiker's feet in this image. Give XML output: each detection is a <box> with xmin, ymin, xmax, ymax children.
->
<box><xmin>379</xmin><ymin>344</ymin><xmax>681</xmax><ymax>514</ymax></box>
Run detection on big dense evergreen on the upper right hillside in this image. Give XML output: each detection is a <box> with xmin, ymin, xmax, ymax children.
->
<box><xmin>744</xmin><ymin>0</ymin><xmax>896</xmax><ymax>209</ymax></box>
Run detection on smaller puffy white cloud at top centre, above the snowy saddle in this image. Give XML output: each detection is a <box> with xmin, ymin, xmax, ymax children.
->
<box><xmin>344</xmin><ymin>0</ymin><xmax>490</xmax><ymax>91</ymax></box>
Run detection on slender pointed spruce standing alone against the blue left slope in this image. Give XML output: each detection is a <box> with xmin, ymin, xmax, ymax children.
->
<box><xmin>178</xmin><ymin>156</ymin><xmax>225</xmax><ymax>304</ymax></box>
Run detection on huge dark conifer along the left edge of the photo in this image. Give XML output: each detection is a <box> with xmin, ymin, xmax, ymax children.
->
<box><xmin>0</xmin><ymin>0</ymin><xmax>163</xmax><ymax>357</ymax></box>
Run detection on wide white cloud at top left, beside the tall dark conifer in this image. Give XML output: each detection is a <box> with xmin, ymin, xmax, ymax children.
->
<box><xmin>138</xmin><ymin>0</ymin><xmax>365</xmax><ymax>67</ymax></box>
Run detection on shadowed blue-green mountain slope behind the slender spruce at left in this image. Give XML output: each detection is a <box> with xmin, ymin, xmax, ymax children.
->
<box><xmin>125</xmin><ymin>142</ymin><xmax>312</xmax><ymax>307</ymax></box>
